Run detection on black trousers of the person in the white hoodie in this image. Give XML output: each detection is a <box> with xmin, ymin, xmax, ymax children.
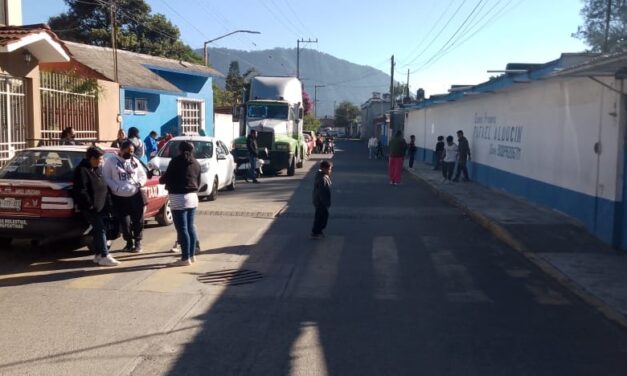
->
<box><xmin>112</xmin><ymin>191</ymin><xmax>145</xmax><ymax>243</ymax></box>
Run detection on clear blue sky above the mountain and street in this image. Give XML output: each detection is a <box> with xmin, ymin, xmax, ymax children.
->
<box><xmin>23</xmin><ymin>0</ymin><xmax>586</xmax><ymax>96</ymax></box>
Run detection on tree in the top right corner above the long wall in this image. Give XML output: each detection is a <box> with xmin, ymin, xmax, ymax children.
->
<box><xmin>573</xmin><ymin>0</ymin><xmax>627</xmax><ymax>53</ymax></box>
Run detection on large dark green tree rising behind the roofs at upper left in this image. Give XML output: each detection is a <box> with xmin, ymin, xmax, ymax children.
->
<box><xmin>48</xmin><ymin>0</ymin><xmax>202</xmax><ymax>63</ymax></box>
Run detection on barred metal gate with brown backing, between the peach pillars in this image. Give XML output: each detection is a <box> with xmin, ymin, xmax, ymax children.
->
<box><xmin>39</xmin><ymin>71</ymin><xmax>98</xmax><ymax>145</ymax></box>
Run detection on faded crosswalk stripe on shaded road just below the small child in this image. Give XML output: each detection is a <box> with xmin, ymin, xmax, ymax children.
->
<box><xmin>293</xmin><ymin>236</ymin><xmax>344</xmax><ymax>298</ymax></box>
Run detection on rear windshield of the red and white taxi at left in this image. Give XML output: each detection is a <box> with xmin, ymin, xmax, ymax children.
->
<box><xmin>0</xmin><ymin>150</ymin><xmax>85</xmax><ymax>182</ymax></box>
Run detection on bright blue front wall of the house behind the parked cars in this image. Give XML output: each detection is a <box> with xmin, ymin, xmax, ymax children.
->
<box><xmin>120</xmin><ymin>66</ymin><xmax>214</xmax><ymax>144</ymax></box>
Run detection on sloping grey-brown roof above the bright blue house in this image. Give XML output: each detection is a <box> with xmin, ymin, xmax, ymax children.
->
<box><xmin>63</xmin><ymin>41</ymin><xmax>223</xmax><ymax>93</ymax></box>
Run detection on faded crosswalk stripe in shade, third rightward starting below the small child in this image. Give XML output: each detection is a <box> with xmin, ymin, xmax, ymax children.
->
<box><xmin>431</xmin><ymin>250</ymin><xmax>490</xmax><ymax>303</ymax></box>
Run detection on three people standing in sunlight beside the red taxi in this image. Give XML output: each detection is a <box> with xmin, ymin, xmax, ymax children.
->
<box><xmin>73</xmin><ymin>138</ymin><xmax>201</xmax><ymax>266</ymax></box>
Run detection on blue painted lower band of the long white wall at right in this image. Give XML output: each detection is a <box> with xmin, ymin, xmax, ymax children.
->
<box><xmin>417</xmin><ymin>148</ymin><xmax>627</xmax><ymax>248</ymax></box>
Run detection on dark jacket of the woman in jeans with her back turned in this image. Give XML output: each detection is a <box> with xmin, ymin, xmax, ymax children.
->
<box><xmin>159</xmin><ymin>154</ymin><xmax>200</xmax><ymax>194</ymax></box>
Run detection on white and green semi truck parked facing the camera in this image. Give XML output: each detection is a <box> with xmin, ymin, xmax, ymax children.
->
<box><xmin>233</xmin><ymin>76</ymin><xmax>306</xmax><ymax>176</ymax></box>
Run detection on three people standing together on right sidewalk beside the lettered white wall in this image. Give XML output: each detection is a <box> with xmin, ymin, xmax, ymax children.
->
<box><xmin>433</xmin><ymin>130</ymin><xmax>471</xmax><ymax>182</ymax></box>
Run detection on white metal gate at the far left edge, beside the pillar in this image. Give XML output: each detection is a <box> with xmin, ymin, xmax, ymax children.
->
<box><xmin>0</xmin><ymin>75</ymin><xmax>26</xmax><ymax>166</ymax></box>
